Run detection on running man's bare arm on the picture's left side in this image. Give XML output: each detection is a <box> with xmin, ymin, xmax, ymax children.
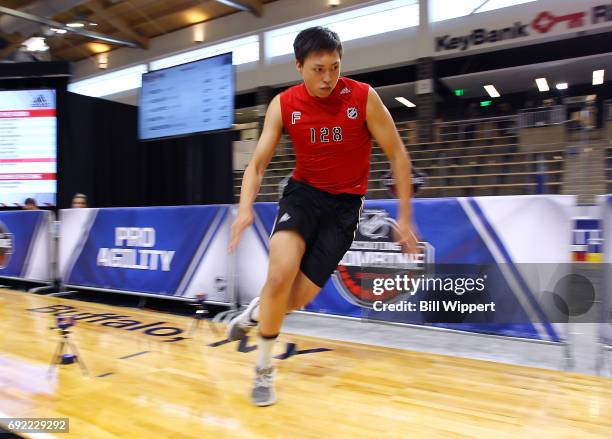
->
<box><xmin>229</xmin><ymin>95</ymin><xmax>283</xmax><ymax>252</ymax></box>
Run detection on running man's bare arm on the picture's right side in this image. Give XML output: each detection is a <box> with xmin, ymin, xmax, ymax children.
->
<box><xmin>366</xmin><ymin>88</ymin><xmax>417</xmax><ymax>253</ymax></box>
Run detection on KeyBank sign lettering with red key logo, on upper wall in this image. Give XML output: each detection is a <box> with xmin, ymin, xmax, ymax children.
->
<box><xmin>435</xmin><ymin>4</ymin><xmax>612</xmax><ymax>52</ymax></box>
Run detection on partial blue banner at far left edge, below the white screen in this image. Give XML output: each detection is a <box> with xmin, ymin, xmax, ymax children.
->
<box><xmin>0</xmin><ymin>210</ymin><xmax>52</xmax><ymax>282</ymax></box>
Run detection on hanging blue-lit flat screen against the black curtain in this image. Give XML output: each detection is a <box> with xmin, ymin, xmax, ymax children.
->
<box><xmin>139</xmin><ymin>52</ymin><xmax>235</xmax><ymax>140</ymax></box>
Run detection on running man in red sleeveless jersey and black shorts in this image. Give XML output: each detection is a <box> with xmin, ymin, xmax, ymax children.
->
<box><xmin>228</xmin><ymin>27</ymin><xmax>417</xmax><ymax>406</ymax></box>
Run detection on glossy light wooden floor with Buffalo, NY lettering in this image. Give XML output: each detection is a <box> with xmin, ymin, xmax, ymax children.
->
<box><xmin>0</xmin><ymin>290</ymin><xmax>612</xmax><ymax>439</ymax></box>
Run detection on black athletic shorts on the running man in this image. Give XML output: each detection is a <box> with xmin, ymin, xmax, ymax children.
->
<box><xmin>272</xmin><ymin>179</ymin><xmax>363</xmax><ymax>287</ymax></box>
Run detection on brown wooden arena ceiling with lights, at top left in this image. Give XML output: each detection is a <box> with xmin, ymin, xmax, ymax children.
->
<box><xmin>0</xmin><ymin>0</ymin><xmax>274</xmax><ymax>61</ymax></box>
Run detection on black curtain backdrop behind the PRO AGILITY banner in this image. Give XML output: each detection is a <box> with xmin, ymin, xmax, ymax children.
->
<box><xmin>58</xmin><ymin>93</ymin><xmax>235</xmax><ymax>208</ymax></box>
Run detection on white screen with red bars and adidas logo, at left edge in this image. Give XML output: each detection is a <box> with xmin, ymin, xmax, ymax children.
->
<box><xmin>0</xmin><ymin>90</ymin><xmax>57</xmax><ymax>206</ymax></box>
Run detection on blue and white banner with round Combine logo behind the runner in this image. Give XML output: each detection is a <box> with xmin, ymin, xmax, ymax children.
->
<box><xmin>237</xmin><ymin>196</ymin><xmax>575</xmax><ymax>341</ymax></box>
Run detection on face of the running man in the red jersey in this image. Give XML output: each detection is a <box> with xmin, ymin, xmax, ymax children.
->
<box><xmin>295</xmin><ymin>50</ymin><xmax>340</xmax><ymax>98</ymax></box>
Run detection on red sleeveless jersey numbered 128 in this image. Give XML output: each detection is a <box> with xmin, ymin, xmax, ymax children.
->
<box><xmin>280</xmin><ymin>78</ymin><xmax>372</xmax><ymax>195</ymax></box>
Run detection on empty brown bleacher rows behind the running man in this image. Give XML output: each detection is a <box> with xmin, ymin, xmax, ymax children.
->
<box><xmin>234</xmin><ymin>118</ymin><xmax>568</xmax><ymax>201</ymax></box>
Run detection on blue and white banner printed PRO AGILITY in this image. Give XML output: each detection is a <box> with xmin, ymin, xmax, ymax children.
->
<box><xmin>59</xmin><ymin>206</ymin><xmax>231</xmax><ymax>303</ymax></box>
